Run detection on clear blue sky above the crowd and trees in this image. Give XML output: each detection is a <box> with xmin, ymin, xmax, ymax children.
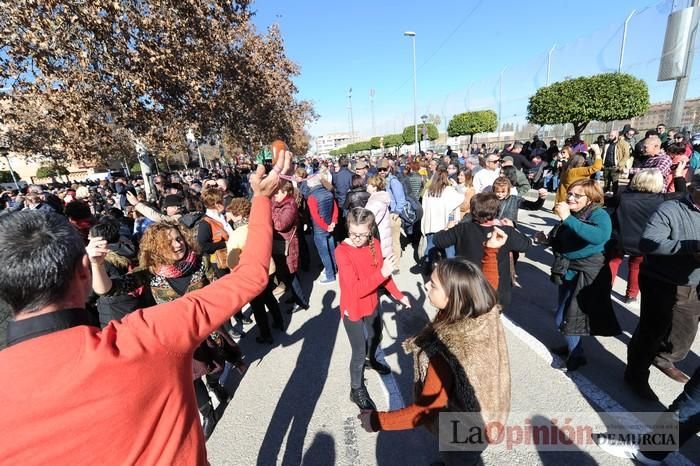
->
<box><xmin>253</xmin><ymin>0</ymin><xmax>700</xmax><ymax>137</ymax></box>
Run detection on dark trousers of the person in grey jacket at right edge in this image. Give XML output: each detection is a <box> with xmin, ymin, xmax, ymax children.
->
<box><xmin>625</xmin><ymin>274</ymin><xmax>700</xmax><ymax>382</ymax></box>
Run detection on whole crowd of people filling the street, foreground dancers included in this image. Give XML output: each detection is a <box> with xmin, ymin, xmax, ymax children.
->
<box><xmin>0</xmin><ymin>125</ymin><xmax>700</xmax><ymax>463</ymax></box>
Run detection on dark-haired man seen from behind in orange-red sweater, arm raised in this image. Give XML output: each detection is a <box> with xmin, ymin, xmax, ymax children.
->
<box><xmin>0</xmin><ymin>152</ymin><xmax>291</xmax><ymax>465</ymax></box>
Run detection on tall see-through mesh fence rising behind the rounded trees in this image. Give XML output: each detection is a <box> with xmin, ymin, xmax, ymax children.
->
<box><xmin>376</xmin><ymin>0</ymin><xmax>700</xmax><ymax>149</ymax></box>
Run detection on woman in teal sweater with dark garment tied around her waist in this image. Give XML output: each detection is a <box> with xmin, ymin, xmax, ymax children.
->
<box><xmin>535</xmin><ymin>179</ymin><xmax>621</xmax><ymax>371</ymax></box>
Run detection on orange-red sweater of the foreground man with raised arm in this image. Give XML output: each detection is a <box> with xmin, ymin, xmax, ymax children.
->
<box><xmin>0</xmin><ymin>196</ymin><xmax>272</xmax><ymax>465</ymax></box>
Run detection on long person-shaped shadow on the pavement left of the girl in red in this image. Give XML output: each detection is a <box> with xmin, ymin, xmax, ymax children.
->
<box><xmin>257</xmin><ymin>290</ymin><xmax>339</xmax><ymax>465</ymax></box>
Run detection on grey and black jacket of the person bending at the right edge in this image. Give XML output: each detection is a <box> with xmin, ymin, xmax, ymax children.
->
<box><xmin>639</xmin><ymin>197</ymin><xmax>700</xmax><ymax>286</ymax></box>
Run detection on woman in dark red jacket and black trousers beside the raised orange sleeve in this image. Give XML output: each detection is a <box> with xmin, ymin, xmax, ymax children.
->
<box><xmin>272</xmin><ymin>181</ymin><xmax>309</xmax><ymax>314</ymax></box>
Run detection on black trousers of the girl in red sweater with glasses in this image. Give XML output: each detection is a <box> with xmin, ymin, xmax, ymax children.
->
<box><xmin>343</xmin><ymin>308</ymin><xmax>382</xmax><ymax>388</ymax></box>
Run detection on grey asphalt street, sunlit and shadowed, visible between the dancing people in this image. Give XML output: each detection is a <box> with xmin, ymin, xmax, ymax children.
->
<box><xmin>207</xmin><ymin>194</ymin><xmax>700</xmax><ymax>465</ymax></box>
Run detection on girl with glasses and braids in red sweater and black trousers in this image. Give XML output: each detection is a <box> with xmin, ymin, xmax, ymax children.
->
<box><xmin>335</xmin><ymin>207</ymin><xmax>409</xmax><ymax>409</ymax></box>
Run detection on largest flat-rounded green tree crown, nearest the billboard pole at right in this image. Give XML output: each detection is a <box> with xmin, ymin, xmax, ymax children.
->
<box><xmin>527</xmin><ymin>73</ymin><xmax>649</xmax><ymax>136</ymax></box>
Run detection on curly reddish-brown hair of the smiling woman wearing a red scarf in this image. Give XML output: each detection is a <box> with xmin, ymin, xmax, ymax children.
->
<box><xmin>139</xmin><ymin>222</ymin><xmax>197</xmax><ymax>271</ymax></box>
